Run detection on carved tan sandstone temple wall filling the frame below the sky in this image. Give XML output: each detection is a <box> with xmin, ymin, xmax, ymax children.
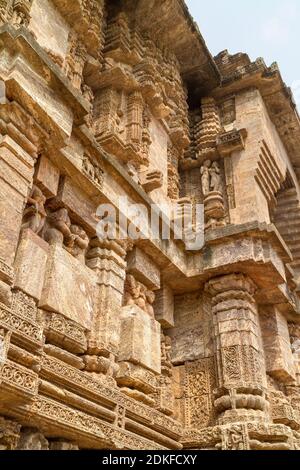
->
<box><xmin>0</xmin><ymin>0</ymin><xmax>300</xmax><ymax>450</ymax></box>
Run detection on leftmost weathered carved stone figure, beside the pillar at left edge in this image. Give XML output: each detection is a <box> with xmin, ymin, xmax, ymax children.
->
<box><xmin>22</xmin><ymin>185</ymin><xmax>47</xmax><ymax>235</ymax></box>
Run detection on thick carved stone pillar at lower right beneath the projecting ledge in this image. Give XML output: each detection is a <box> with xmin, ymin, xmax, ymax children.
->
<box><xmin>205</xmin><ymin>274</ymin><xmax>267</xmax><ymax>424</ymax></box>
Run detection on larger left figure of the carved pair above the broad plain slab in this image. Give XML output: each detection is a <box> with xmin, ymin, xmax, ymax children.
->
<box><xmin>44</xmin><ymin>208</ymin><xmax>75</xmax><ymax>246</ymax></box>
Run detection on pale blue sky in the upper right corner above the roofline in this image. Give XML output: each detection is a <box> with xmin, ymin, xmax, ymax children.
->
<box><xmin>186</xmin><ymin>0</ymin><xmax>300</xmax><ymax>107</ymax></box>
